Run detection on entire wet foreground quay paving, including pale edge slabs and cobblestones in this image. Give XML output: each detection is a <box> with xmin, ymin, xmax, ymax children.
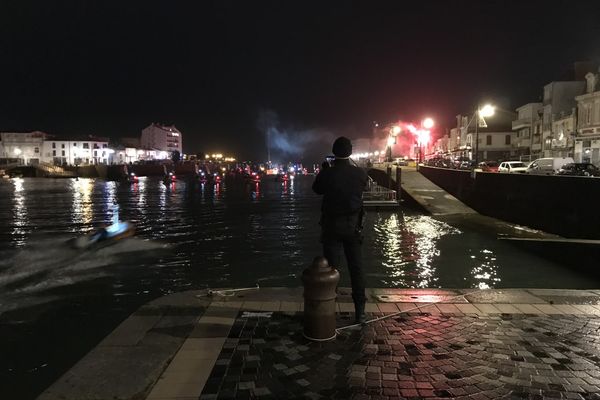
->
<box><xmin>40</xmin><ymin>288</ymin><xmax>600</xmax><ymax>400</ymax></box>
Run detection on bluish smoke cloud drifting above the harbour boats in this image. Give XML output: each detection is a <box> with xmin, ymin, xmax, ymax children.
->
<box><xmin>257</xmin><ymin>110</ymin><xmax>336</xmax><ymax>162</ymax></box>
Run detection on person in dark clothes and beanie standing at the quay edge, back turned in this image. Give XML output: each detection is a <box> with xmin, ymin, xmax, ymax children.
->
<box><xmin>312</xmin><ymin>136</ymin><xmax>368</xmax><ymax>323</ymax></box>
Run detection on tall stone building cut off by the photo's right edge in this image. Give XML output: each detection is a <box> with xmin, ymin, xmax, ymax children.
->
<box><xmin>574</xmin><ymin>73</ymin><xmax>600</xmax><ymax>164</ymax></box>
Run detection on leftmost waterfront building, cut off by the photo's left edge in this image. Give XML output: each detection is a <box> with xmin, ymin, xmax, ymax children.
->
<box><xmin>0</xmin><ymin>131</ymin><xmax>48</xmax><ymax>165</ymax></box>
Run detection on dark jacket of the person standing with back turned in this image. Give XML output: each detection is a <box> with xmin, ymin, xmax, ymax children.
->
<box><xmin>313</xmin><ymin>159</ymin><xmax>368</xmax><ymax>217</ymax></box>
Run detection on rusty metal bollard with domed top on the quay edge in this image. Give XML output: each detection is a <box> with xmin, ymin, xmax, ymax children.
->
<box><xmin>302</xmin><ymin>257</ymin><xmax>340</xmax><ymax>341</ymax></box>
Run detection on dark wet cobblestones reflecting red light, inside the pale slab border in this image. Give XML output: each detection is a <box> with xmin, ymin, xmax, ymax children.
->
<box><xmin>200</xmin><ymin>312</ymin><xmax>600</xmax><ymax>400</ymax></box>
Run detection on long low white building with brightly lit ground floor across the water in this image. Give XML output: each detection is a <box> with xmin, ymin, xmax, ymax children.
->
<box><xmin>42</xmin><ymin>135</ymin><xmax>112</xmax><ymax>165</ymax></box>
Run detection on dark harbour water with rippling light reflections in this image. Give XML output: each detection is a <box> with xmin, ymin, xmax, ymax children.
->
<box><xmin>0</xmin><ymin>177</ymin><xmax>599</xmax><ymax>399</ymax></box>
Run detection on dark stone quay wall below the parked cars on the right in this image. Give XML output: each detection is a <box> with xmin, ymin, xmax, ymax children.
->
<box><xmin>420</xmin><ymin>167</ymin><xmax>600</xmax><ymax>239</ymax></box>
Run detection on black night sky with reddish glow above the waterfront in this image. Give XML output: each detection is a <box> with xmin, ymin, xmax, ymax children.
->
<box><xmin>0</xmin><ymin>0</ymin><xmax>600</xmax><ymax>159</ymax></box>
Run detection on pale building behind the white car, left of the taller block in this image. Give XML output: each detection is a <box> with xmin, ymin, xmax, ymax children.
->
<box><xmin>512</xmin><ymin>103</ymin><xmax>543</xmax><ymax>161</ymax></box>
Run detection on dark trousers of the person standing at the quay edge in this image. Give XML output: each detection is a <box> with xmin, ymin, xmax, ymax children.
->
<box><xmin>321</xmin><ymin>216</ymin><xmax>366</xmax><ymax>304</ymax></box>
